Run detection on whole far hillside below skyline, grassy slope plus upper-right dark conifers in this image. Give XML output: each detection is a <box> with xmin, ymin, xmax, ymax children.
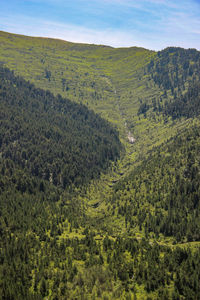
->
<box><xmin>0</xmin><ymin>32</ymin><xmax>199</xmax><ymax>164</ymax></box>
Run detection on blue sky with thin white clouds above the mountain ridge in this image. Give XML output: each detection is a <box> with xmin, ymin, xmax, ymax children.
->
<box><xmin>0</xmin><ymin>0</ymin><xmax>200</xmax><ymax>50</ymax></box>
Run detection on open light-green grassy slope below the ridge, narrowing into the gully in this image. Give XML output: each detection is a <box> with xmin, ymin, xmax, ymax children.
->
<box><xmin>0</xmin><ymin>32</ymin><xmax>192</xmax><ymax>169</ymax></box>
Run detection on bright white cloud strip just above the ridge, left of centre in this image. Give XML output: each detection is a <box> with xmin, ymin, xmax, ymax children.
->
<box><xmin>0</xmin><ymin>17</ymin><xmax>146</xmax><ymax>47</ymax></box>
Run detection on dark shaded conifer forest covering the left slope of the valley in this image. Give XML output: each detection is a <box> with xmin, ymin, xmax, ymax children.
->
<box><xmin>0</xmin><ymin>67</ymin><xmax>121</xmax><ymax>190</ymax></box>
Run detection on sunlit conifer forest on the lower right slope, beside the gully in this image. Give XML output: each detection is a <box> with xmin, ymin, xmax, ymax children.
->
<box><xmin>111</xmin><ymin>125</ymin><xmax>200</xmax><ymax>242</ymax></box>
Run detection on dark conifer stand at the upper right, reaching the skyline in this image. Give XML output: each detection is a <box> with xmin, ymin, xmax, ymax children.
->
<box><xmin>138</xmin><ymin>47</ymin><xmax>200</xmax><ymax>119</ymax></box>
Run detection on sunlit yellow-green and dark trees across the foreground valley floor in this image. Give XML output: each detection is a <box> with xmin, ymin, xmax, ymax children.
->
<box><xmin>0</xmin><ymin>171</ymin><xmax>200</xmax><ymax>300</ymax></box>
